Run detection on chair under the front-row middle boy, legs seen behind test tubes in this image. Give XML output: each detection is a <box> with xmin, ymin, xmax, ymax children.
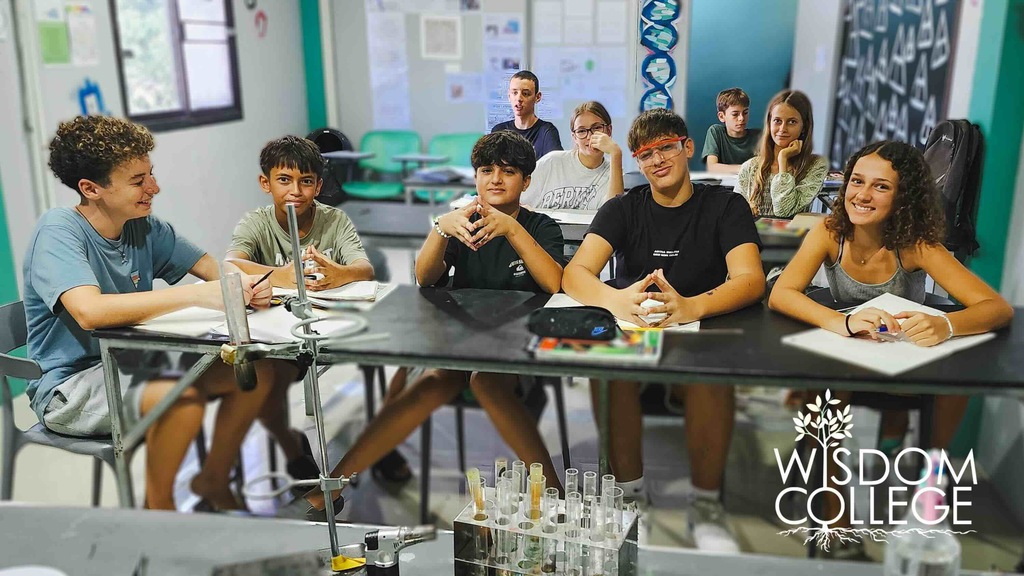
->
<box><xmin>420</xmin><ymin>376</ymin><xmax>572</xmax><ymax>524</ymax></box>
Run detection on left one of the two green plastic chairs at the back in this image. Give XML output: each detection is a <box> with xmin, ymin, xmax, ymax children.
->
<box><xmin>344</xmin><ymin>130</ymin><xmax>420</xmax><ymax>200</ymax></box>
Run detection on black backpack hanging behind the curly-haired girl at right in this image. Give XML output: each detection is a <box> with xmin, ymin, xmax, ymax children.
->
<box><xmin>925</xmin><ymin>120</ymin><xmax>983</xmax><ymax>261</ymax></box>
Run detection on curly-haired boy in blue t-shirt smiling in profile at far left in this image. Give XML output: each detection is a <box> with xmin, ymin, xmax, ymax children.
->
<box><xmin>23</xmin><ymin>116</ymin><xmax>270</xmax><ymax>509</ymax></box>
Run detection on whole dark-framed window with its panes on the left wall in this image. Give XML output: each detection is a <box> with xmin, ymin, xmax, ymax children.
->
<box><xmin>111</xmin><ymin>0</ymin><xmax>242</xmax><ymax>131</ymax></box>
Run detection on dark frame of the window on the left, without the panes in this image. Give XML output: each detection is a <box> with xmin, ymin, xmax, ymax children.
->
<box><xmin>110</xmin><ymin>0</ymin><xmax>244</xmax><ymax>132</ymax></box>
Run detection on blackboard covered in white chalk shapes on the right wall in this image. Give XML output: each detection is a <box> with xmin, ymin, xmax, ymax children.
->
<box><xmin>829</xmin><ymin>0</ymin><xmax>961</xmax><ymax>169</ymax></box>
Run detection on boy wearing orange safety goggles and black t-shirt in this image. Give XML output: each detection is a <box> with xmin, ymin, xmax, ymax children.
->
<box><xmin>562</xmin><ymin>110</ymin><xmax>765</xmax><ymax>552</ymax></box>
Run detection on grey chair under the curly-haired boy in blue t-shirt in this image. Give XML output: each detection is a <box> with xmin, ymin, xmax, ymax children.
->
<box><xmin>0</xmin><ymin>301</ymin><xmax>127</xmax><ymax>506</ymax></box>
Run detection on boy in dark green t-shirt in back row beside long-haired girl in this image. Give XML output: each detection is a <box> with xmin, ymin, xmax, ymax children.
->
<box><xmin>700</xmin><ymin>88</ymin><xmax>761</xmax><ymax>174</ymax></box>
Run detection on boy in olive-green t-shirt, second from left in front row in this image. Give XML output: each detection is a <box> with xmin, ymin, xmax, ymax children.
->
<box><xmin>225</xmin><ymin>136</ymin><xmax>374</xmax><ymax>479</ymax></box>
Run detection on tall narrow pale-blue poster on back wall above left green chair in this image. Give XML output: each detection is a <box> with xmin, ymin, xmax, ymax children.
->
<box><xmin>367</xmin><ymin>11</ymin><xmax>413</xmax><ymax>130</ymax></box>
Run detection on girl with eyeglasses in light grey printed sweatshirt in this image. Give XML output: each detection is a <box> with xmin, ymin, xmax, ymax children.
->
<box><xmin>522</xmin><ymin>100</ymin><xmax>623</xmax><ymax>210</ymax></box>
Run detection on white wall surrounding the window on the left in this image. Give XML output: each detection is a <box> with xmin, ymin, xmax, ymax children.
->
<box><xmin>0</xmin><ymin>0</ymin><xmax>308</xmax><ymax>278</ymax></box>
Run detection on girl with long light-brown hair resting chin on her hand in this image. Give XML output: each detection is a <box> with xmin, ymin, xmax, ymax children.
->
<box><xmin>736</xmin><ymin>90</ymin><xmax>828</xmax><ymax>218</ymax></box>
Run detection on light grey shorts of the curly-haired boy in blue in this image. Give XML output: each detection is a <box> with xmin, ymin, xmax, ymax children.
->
<box><xmin>43</xmin><ymin>364</ymin><xmax>146</xmax><ymax>437</ymax></box>
